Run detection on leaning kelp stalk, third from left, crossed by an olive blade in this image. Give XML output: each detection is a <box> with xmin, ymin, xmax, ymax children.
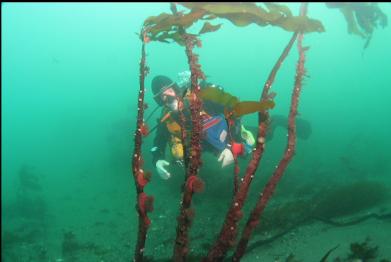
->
<box><xmin>204</xmin><ymin>22</ymin><xmax>297</xmax><ymax>261</ymax></box>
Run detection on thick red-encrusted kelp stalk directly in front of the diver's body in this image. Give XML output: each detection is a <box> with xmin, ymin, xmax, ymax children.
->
<box><xmin>171</xmin><ymin>5</ymin><xmax>205</xmax><ymax>261</ymax></box>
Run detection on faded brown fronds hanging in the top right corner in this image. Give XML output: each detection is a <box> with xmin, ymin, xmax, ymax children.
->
<box><xmin>326</xmin><ymin>3</ymin><xmax>387</xmax><ymax>38</ymax></box>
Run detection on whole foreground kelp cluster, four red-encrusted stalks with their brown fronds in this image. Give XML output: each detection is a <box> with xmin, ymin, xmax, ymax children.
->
<box><xmin>133</xmin><ymin>3</ymin><xmax>384</xmax><ymax>261</ymax></box>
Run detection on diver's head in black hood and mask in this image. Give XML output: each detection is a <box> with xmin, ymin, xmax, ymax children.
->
<box><xmin>152</xmin><ymin>75</ymin><xmax>180</xmax><ymax>111</ymax></box>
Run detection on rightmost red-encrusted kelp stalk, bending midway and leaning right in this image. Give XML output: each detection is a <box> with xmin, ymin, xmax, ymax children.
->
<box><xmin>232</xmin><ymin>3</ymin><xmax>308</xmax><ymax>261</ymax></box>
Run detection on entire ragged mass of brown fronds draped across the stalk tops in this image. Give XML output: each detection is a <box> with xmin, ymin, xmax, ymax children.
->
<box><xmin>144</xmin><ymin>2</ymin><xmax>324</xmax><ymax>45</ymax></box>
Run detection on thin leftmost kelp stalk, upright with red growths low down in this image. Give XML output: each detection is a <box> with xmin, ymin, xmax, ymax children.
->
<box><xmin>132</xmin><ymin>31</ymin><xmax>153</xmax><ymax>261</ymax></box>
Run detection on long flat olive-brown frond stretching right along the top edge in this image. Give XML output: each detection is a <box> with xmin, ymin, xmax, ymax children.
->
<box><xmin>180</xmin><ymin>2</ymin><xmax>324</xmax><ymax>33</ymax></box>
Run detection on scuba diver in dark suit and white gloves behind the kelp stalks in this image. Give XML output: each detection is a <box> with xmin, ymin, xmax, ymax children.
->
<box><xmin>151</xmin><ymin>72</ymin><xmax>255</xmax><ymax>179</ymax></box>
